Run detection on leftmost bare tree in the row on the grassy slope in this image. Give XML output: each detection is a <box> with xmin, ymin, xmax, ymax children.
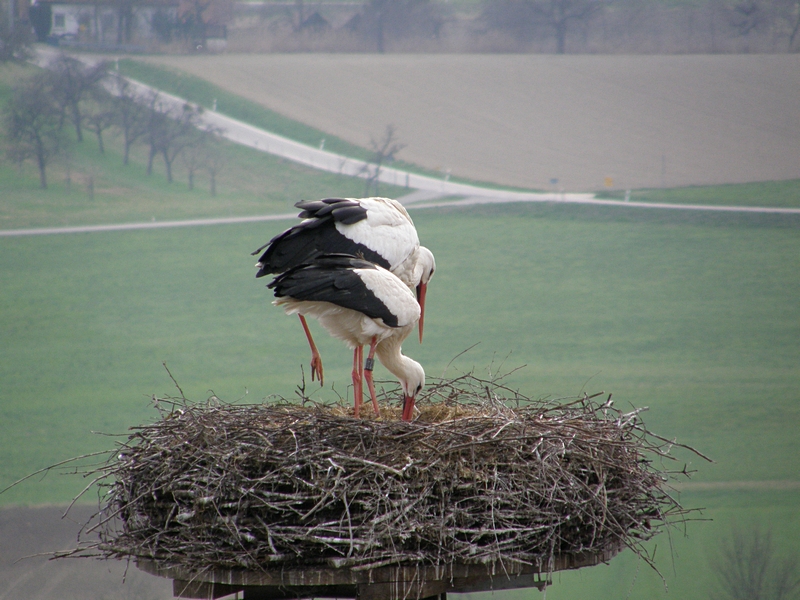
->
<box><xmin>4</xmin><ymin>73</ymin><xmax>66</xmax><ymax>189</ymax></box>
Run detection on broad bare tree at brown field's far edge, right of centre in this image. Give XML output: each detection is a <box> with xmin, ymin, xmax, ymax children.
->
<box><xmin>482</xmin><ymin>0</ymin><xmax>606</xmax><ymax>54</ymax></box>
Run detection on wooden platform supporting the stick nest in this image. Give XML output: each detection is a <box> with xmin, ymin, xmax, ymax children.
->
<box><xmin>137</xmin><ymin>548</ymin><xmax>619</xmax><ymax>600</ymax></box>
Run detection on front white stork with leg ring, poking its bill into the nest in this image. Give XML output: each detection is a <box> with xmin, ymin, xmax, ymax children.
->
<box><xmin>267</xmin><ymin>254</ymin><xmax>425</xmax><ymax>421</ymax></box>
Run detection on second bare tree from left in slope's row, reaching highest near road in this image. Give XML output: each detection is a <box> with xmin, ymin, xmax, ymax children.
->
<box><xmin>50</xmin><ymin>54</ymin><xmax>108</xmax><ymax>142</ymax></box>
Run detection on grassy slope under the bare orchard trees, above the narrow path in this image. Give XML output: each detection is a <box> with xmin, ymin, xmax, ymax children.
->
<box><xmin>0</xmin><ymin>66</ymin><xmax>401</xmax><ymax>229</ymax></box>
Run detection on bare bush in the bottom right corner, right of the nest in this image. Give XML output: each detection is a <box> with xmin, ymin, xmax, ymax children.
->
<box><xmin>712</xmin><ymin>527</ymin><xmax>800</xmax><ymax>600</ymax></box>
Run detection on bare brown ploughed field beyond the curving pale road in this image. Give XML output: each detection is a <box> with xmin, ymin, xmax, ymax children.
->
<box><xmin>147</xmin><ymin>54</ymin><xmax>800</xmax><ymax>191</ymax></box>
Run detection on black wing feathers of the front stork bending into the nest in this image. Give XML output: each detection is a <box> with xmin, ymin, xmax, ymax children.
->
<box><xmin>267</xmin><ymin>254</ymin><xmax>398</xmax><ymax>327</ymax></box>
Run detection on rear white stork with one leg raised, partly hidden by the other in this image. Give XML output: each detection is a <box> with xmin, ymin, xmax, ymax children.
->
<box><xmin>253</xmin><ymin>198</ymin><xmax>436</xmax><ymax>385</ymax></box>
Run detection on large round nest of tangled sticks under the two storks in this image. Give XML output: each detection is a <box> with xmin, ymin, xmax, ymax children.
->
<box><xmin>70</xmin><ymin>374</ymin><xmax>708</xmax><ymax>571</ymax></box>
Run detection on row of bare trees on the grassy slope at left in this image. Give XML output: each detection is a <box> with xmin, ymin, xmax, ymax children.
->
<box><xmin>3</xmin><ymin>54</ymin><xmax>223</xmax><ymax>195</ymax></box>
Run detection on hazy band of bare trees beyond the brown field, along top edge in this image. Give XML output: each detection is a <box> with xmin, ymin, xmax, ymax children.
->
<box><xmin>276</xmin><ymin>0</ymin><xmax>800</xmax><ymax>54</ymax></box>
